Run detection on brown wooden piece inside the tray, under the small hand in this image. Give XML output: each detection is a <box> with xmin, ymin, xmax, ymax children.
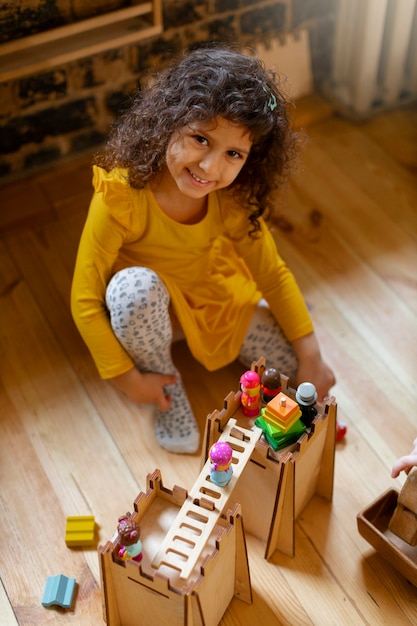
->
<box><xmin>388</xmin><ymin>467</ymin><xmax>417</xmax><ymax>546</ymax></box>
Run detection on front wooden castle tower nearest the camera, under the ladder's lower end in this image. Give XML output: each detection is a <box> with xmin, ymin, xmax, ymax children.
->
<box><xmin>99</xmin><ymin>470</ymin><xmax>252</xmax><ymax>626</ymax></box>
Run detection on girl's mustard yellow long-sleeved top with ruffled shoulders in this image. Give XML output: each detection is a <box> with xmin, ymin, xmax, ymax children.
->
<box><xmin>71</xmin><ymin>166</ymin><xmax>313</xmax><ymax>378</ymax></box>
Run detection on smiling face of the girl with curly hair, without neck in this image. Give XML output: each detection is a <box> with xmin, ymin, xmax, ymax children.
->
<box><xmin>166</xmin><ymin>117</ymin><xmax>252</xmax><ymax>199</ymax></box>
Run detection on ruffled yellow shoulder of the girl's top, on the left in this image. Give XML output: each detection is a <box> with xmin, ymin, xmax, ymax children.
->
<box><xmin>93</xmin><ymin>165</ymin><xmax>137</xmax><ymax>230</ymax></box>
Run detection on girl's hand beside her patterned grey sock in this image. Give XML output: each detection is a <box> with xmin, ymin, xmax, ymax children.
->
<box><xmin>111</xmin><ymin>367</ymin><xmax>177</xmax><ymax>411</ymax></box>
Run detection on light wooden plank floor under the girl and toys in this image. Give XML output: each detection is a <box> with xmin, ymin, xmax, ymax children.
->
<box><xmin>0</xmin><ymin>100</ymin><xmax>417</xmax><ymax>626</ymax></box>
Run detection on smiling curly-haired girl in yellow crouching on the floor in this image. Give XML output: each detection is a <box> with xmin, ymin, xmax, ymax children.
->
<box><xmin>72</xmin><ymin>48</ymin><xmax>334</xmax><ymax>453</ymax></box>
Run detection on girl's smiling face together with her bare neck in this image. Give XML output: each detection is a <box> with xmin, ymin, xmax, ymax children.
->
<box><xmin>153</xmin><ymin>117</ymin><xmax>252</xmax><ymax>222</ymax></box>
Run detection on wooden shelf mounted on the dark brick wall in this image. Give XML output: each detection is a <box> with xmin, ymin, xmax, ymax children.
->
<box><xmin>0</xmin><ymin>0</ymin><xmax>162</xmax><ymax>82</ymax></box>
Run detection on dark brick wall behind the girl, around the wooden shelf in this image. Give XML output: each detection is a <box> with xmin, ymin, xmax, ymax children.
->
<box><xmin>0</xmin><ymin>0</ymin><xmax>338</xmax><ymax>182</ymax></box>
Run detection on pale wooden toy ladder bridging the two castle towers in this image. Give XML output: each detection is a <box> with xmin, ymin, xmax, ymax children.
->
<box><xmin>152</xmin><ymin>419</ymin><xmax>262</xmax><ymax>579</ymax></box>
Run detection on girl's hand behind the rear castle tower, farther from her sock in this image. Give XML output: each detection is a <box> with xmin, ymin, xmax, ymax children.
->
<box><xmin>293</xmin><ymin>333</ymin><xmax>336</xmax><ymax>402</ymax></box>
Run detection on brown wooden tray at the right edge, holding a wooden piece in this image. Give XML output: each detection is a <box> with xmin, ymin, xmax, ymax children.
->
<box><xmin>357</xmin><ymin>489</ymin><xmax>417</xmax><ymax>587</ymax></box>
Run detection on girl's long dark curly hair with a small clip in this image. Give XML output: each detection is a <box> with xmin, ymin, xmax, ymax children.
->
<box><xmin>95</xmin><ymin>46</ymin><xmax>299</xmax><ymax>234</ymax></box>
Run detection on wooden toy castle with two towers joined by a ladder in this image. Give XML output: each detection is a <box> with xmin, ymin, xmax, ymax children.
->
<box><xmin>99</xmin><ymin>359</ymin><xmax>337</xmax><ymax>626</ymax></box>
